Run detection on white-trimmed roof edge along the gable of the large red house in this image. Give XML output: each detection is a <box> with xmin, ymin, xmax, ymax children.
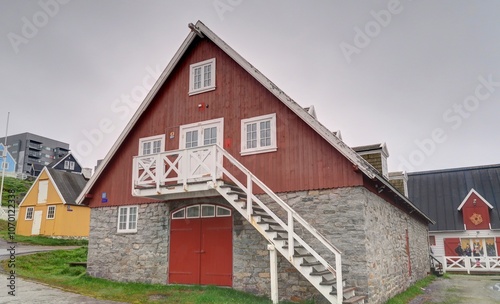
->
<box><xmin>77</xmin><ymin>21</ymin><xmax>431</xmax><ymax>221</ymax></box>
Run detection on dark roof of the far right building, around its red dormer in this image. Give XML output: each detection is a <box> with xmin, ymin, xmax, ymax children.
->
<box><xmin>408</xmin><ymin>164</ymin><xmax>500</xmax><ymax>231</ymax></box>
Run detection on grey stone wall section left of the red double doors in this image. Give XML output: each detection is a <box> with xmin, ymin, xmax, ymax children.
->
<box><xmin>87</xmin><ymin>203</ymin><xmax>169</xmax><ymax>283</ymax></box>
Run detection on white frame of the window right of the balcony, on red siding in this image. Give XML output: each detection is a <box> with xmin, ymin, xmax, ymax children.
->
<box><xmin>240</xmin><ymin>113</ymin><xmax>278</xmax><ymax>155</ymax></box>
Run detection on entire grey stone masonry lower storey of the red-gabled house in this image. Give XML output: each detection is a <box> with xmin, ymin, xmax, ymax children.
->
<box><xmin>87</xmin><ymin>187</ymin><xmax>429</xmax><ymax>303</ymax></box>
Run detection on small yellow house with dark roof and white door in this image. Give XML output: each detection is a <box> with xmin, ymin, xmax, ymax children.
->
<box><xmin>16</xmin><ymin>167</ymin><xmax>90</xmax><ymax>237</ymax></box>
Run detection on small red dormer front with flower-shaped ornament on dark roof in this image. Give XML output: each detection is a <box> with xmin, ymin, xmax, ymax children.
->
<box><xmin>462</xmin><ymin>193</ymin><xmax>490</xmax><ymax>230</ymax></box>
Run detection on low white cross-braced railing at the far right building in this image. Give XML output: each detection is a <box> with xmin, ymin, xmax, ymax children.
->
<box><xmin>442</xmin><ymin>256</ymin><xmax>500</xmax><ymax>273</ymax></box>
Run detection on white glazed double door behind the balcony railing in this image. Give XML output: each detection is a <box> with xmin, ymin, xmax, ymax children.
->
<box><xmin>179</xmin><ymin>118</ymin><xmax>224</xmax><ymax>180</ymax></box>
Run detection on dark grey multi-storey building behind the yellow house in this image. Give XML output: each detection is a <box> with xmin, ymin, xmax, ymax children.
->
<box><xmin>0</xmin><ymin>133</ymin><xmax>69</xmax><ymax>176</ymax></box>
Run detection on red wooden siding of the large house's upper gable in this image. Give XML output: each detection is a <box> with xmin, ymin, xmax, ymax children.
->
<box><xmin>84</xmin><ymin>38</ymin><xmax>363</xmax><ymax>206</ymax></box>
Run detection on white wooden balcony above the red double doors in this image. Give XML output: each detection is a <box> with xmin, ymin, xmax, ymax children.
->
<box><xmin>132</xmin><ymin>145</ymin><xmax>222</xmax><ymax>200</ymax></box>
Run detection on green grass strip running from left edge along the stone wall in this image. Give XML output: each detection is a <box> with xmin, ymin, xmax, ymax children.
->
<box><xmin>2</xmin><ymin>247</ymin><xmax>311</xmax><ymax>304</ymax></box>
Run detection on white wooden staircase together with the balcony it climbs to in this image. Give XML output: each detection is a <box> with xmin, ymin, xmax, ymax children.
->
<box><xmin>133</xmin><ymin>145</ymin><xmax>366</xmax><ymax>304</ymax></box>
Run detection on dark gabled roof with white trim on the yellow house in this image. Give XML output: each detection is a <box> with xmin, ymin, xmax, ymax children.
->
<box><xmin>19</xmin><ymin>167</ymin><xmax>87</xmax><ymax>206</ymax></box>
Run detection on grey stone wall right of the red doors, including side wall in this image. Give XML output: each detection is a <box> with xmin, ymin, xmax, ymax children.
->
<box><xmin>234</xmin><ymin>187</ymin><xmax>429</xmax><ymax>303</ymax></box>
